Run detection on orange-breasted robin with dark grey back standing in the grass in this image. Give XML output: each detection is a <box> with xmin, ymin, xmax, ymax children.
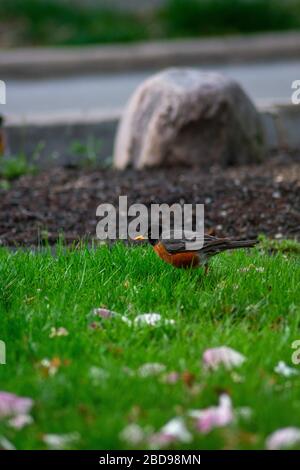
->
<box><xmin>135</xmin><ymin>227</ymin><xmax>257</xmax><ymax>272</ymax></box>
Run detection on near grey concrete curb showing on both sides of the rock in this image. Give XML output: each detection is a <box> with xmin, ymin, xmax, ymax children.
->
<box><xmin>5</xmin><ymin>103</ymin><xmax>300</xmax><ymax>168</ymax></box>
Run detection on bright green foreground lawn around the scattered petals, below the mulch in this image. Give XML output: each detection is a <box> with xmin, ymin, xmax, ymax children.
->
<box><xmin>0</xmin><ymin>243</ymin><xmax>300</xmax><ymax>449</ymax></box>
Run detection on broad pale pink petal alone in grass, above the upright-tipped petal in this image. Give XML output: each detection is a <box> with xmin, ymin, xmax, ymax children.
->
<box><xmin>203</xmin><ymin>346</ymin><xmax>246</xmax><ymax>370</ymax></box>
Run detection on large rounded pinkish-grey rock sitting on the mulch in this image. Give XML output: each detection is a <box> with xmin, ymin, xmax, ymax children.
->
<box><xmin>114</xmin><ymin>68</ymin><xmax>264</xmax><ymax>169</ymax></box>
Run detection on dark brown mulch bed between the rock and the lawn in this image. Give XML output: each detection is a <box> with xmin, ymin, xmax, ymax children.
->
<box><xmin>0</xmin><ymin>156</ymin><xmax>300</xmax><ymax>246</ymax></box>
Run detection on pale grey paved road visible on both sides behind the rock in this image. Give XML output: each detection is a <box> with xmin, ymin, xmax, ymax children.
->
<box><xmin>0</xmin><ymin>61</ymin><xmax>300</xmax><ymax>115</ymax></box>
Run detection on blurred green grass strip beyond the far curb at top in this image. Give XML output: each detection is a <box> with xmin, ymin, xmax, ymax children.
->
<box><xmin>0</xmin><ymin>0</ymin><xmax>300</xmax><ymax>46</ymax></box>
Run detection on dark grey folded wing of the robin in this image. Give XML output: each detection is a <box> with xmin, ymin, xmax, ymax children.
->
<box><xmin>161</xmin><ymin>230</ymin><xmax>220</xmax><ymax>254</ymax></box>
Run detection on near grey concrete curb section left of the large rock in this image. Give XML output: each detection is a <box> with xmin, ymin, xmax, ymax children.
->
<box><xmin>5</xmin><ymin>111</ymin><xmax>121</xmax><ymax>168</ymax></box>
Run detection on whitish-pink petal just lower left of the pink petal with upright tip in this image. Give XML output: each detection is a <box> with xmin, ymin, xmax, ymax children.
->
<box><xmin>149</xmin><ymin>417</ymin><xmax>193</xmax><ymax>447</ymax></box>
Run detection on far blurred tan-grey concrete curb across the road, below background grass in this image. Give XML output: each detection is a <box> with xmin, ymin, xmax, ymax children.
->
<box><xmin>0</xmin><ymin>32</ymin><xmax>300</xmax><ymax>79</ymax></box>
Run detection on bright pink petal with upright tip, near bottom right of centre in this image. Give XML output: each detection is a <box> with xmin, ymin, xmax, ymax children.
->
<box><xmin>189</xmin><ymin>394</ymin><xmax>234</xmax><ymax>434</ymax></box>
